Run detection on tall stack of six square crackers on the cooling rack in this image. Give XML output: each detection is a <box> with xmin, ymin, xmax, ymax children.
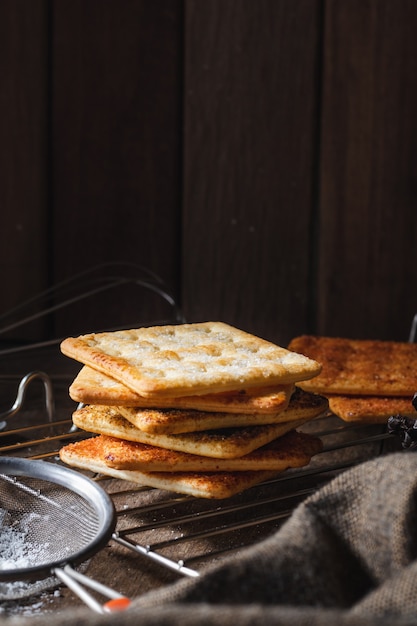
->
<box><xmin>60</xmin><ymin>322</ymin><xmax>328</xmax><ymax>498</ymax></box>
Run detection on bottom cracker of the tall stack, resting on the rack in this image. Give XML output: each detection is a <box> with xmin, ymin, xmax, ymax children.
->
<box><xmin>60</xmin><ymin>440</ymin><xmax>279</xmax><ymax>499</ymax></box>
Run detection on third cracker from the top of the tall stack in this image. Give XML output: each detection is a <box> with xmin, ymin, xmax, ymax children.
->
<box><xmin>118</xmin><ymin>389</ymin><xmax>328</xmax><ymax>434</ymax></box>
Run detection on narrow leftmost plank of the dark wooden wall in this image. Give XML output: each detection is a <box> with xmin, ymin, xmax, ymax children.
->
<box><xmin>0</xmin><ymin>0</ymin><xmax>48</xmax><ymax>340</ymax></box>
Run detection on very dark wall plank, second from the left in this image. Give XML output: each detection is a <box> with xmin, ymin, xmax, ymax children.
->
<box><xmin>52</xmin><ymin>0</ymin><xmax>182</xmax><ymax>332</ymax></box>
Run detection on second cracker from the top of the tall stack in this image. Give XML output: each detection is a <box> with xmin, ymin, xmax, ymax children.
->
<box><xmin>69</xmin><ymin>365</ymin><xmax>294</xmax><ymax>415</ymax></box>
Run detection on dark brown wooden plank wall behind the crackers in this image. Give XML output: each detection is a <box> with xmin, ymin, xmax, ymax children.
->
<box><xmin>0</xmin><ymin>0</ymin><xmax>417</xmax><ymax>344</ymax></box>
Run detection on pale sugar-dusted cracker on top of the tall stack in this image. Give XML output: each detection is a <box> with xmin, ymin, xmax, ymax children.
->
<box><xmin>61</xmin><ymin>322</ymin><xmax>321</xmax><ymax>398</ymax></box>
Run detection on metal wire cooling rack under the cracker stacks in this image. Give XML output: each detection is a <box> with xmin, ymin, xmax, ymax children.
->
<box><xmin>0</xmin><ymin>277</ymin><xmax>410</xmax><ymax>600</ymax></box>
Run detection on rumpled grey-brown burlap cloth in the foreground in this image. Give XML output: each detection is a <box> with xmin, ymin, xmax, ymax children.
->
<box><xmin>4</xmin><ymin>451</ymin><xmax>417</xmax><ymax>626</ymax></box>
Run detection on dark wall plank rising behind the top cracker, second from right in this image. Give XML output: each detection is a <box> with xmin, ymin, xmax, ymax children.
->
<box><xmin>182</xmin><ymin>0</ymin><xmax>319</xmax><ymax>342</ymax></box>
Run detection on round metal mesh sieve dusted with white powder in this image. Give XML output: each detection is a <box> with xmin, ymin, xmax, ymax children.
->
<box><xmin>0</xmin><ymin>457</ymin><xmax>130</xmax><ymax>612</ymax></box>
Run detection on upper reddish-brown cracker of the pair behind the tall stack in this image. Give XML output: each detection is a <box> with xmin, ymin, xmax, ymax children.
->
<box><xmin>289</xmin><ymin>335</ymin><xmax>417</xmax><ymax>396</ymax></box>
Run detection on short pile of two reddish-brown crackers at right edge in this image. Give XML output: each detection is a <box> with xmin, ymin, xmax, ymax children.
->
<box><xmin>288</xmin><ymin>335</ymin><xmax>417</xmax><ymax>423</ymax></box>
